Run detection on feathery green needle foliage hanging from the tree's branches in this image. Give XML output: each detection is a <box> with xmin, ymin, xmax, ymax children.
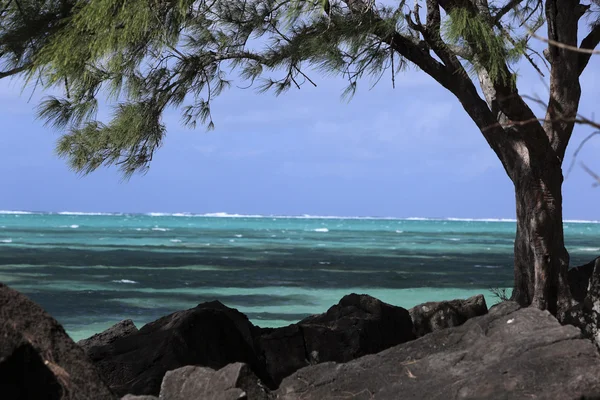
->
<box><xmin>0</xmin><ymin>0</ymin><xmax>596</xmax><ymax>176</ymax></box>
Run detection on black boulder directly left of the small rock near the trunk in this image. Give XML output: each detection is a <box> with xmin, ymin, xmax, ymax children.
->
<box><xmin>259</xmin><ymin>294</ymin><xmax>415</xmax><ymax>384</ymax></box>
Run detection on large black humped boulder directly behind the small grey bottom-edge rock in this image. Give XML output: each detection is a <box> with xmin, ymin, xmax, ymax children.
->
<box><xmin>88</xmin><ymin>301</ymin><xmax>268</xmax><ymax>395</ymax></box>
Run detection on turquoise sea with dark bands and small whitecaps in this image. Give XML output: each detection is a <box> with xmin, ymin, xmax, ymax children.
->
<box><xmin>0</xmin><ymin>212</ymin><xmax>600</xmax><ymax>339</ymax></box>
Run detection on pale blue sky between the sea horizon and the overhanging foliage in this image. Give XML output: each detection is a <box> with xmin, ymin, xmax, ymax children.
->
<box><xmin>0</xmin><ymin>41</ymin><xmax>600</xmax><ymax>220</ymax></box>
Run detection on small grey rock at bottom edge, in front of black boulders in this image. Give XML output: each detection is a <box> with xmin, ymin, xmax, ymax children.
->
<box><xmin>160</xmin><ymin>363</ymin><xmax>270</xmax><ymax>400</ymax></box>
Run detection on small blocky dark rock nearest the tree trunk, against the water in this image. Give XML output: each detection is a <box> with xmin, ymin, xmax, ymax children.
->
<box><xmin>409</xmin><ymin>294</ymin><xmax>487</xmax><ymax>337</ymax></box>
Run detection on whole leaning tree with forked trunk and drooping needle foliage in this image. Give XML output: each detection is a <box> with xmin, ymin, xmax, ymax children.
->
<box><xmin>0</xmin><ymin>0</ymin><xmax>600</xmax><ymax>314</ymax></box>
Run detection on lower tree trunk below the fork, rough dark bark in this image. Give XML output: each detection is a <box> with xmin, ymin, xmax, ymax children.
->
<box><xmin>512</xmin><ymin>151</ymin><xmax>572</xmax><ymax>316</ymax></box>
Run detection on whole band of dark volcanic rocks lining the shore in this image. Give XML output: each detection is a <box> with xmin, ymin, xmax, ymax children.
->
<box><xmin>0</xmin><ymin>262</ymin><xmax>600</xmax><ymax>400</ymax></box>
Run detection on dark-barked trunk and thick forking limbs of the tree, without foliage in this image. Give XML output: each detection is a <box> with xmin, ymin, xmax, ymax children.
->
<box><xmin>332</xmin><ymin>0</ymin><xmax>600</xmax><ymax>319</ymax></box>
